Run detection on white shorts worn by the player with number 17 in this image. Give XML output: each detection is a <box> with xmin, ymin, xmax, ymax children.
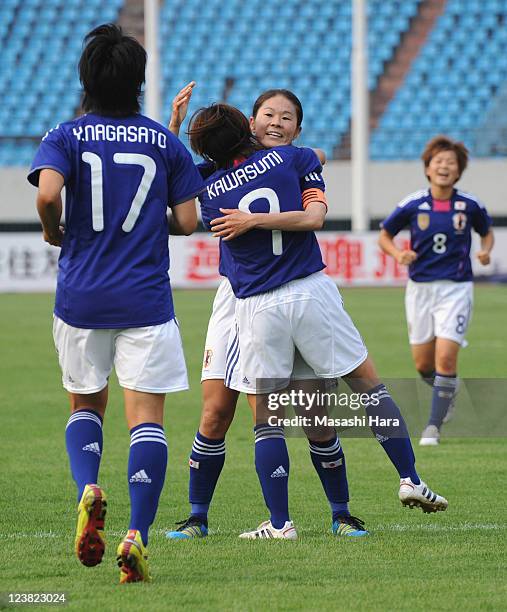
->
<box><xmin>53</xmin><ymin>316</ymin><xmax>188</xmax><ymax>394</ymax></box>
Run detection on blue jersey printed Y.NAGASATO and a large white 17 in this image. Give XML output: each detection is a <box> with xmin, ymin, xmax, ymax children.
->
<box><xmin>28</xmin><ymin>114</ymin><xmax>203</xmax><ymax>328</ymax></box>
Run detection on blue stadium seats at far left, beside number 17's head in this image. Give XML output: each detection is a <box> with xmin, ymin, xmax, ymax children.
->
<box><xmin>0</xmin><ymin>0</ymin><xmax>123</xmax><ymax>166</ymax></box>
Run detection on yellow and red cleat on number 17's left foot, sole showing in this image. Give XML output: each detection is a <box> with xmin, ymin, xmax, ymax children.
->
<box><xmin>75</xmin><ymin>484</ymin><xmax>107</xmax><ymax>567</ymax></box>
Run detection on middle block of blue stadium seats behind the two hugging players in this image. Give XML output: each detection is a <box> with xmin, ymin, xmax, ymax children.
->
<box><xmin>161</xmin><ymin>0</ymin><xmax>419</xmax><ymax>157</ymax></box>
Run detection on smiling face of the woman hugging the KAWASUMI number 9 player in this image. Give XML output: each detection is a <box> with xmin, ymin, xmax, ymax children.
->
<box><xmin>250</xmin><ymin>94</ymin><xmax>301</xmax><ymax>147</ymax></box>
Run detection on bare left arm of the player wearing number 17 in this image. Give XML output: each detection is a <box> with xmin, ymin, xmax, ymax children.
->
<box><xmin>37</xmin><ymin>168</ymin><xmax>64</xmax><ymax>246</ymax></box>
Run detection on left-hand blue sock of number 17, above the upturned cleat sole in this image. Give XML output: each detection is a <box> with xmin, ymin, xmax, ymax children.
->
<box><xmin>65</xmin><ymin>408</ymin><xmax>102</xmax><ymax>502</ymax></box>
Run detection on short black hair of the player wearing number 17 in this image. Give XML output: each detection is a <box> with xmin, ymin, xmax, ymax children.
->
<box><xmin>79</xmin><ymin>23</ymin><xmax>146</xmax><ymax>117</ymax></box>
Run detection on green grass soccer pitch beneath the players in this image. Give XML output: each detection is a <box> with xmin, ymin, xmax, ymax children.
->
<box><xmin>0</xmin><ymin>286</ymin><xmax>507</xmax><ymax>611</ymax></box>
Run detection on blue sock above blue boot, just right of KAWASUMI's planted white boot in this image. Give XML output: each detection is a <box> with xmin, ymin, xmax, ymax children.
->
<box><xmin>309</xmin><ymin>436</ymin><xmax>350</xmax><ymax>521</ymax></box>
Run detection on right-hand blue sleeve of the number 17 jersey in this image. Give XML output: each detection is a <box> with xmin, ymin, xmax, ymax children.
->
<box><xmin>168</xmin><ymin>135</ymin><xmax>204</xmax><ymax>207</ymax></box>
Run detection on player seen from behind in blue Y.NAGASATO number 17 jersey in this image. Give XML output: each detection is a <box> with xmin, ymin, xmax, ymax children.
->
<box><xmin>28</xmin><ymin>25</ymin><xmax>203</xmax><ymax>583</ymax></box>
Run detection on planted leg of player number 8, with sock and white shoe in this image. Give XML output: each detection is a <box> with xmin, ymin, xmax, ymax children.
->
<box><xmin>419</xmin><ymin>338</ymin><xmax>461</xmax><ymax>446</ymax></box>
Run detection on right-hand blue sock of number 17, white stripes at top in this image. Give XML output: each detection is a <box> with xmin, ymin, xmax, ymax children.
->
<box><xmin>128</xmin><ymin>423</ymin><xmax>167</xmax><ymax>546</ymax></box>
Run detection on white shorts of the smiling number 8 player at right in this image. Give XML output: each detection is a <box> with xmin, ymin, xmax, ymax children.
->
<box><xmin>405</xmin><ymin>280</ymin><xmax>474</xmax><ymax>345</ymax></box>
